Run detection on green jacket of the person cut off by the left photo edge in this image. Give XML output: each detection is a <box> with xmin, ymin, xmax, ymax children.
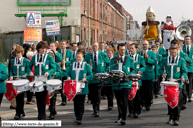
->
<box><xmin>0</xmin><ymin>63</ymin><xmax>8</xmax><ymax>93</ymax></box>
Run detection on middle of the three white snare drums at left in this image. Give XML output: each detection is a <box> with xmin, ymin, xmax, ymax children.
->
<box><xmin>29</xmin><ymin>81</ymin><xmax>44</xmax><ymax>92</ymax></box>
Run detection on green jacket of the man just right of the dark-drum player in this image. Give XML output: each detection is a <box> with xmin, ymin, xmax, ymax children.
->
<box><xmin>133</xmin><ymin>54</ymin><xmax>146</xmax><ymax>86</ymax></box>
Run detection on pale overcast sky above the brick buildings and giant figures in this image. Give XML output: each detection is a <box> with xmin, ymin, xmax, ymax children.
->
<box><xmin>117</xmin><ymin>0</ymin><xmax>193</xmax><ymax>26</ymax></box>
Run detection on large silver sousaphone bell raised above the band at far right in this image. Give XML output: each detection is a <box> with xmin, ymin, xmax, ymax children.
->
<box><xmin>176</xmin><ymin>25</ymin><xmax>192</xmax><ymax>40</ymax></box>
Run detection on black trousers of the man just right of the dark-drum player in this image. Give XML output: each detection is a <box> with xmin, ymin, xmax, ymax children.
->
<box><xmin>128</xmin><ymin>89</ymin><xmax>141</xmax><ymax>114</ymax></box>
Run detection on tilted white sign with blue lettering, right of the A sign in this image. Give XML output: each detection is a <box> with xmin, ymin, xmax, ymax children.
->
<box><xmin>45</xmin><ymin>20</ymin><xmax>60</xmax><ymax>36</ymax></box>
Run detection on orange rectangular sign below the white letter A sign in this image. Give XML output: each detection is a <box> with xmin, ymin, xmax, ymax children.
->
<box><xmin>23</xmin><ymin>28</ymin><xmax>42</xmax><ymax>44</ymax></box>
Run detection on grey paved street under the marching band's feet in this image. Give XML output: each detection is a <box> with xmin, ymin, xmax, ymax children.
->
<box><xmin>0</xmin><ymin>95</ymin><xmax>193</xmax><ymax>128</ymax></box>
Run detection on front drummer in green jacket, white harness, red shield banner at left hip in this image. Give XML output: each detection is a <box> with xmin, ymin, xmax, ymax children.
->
<box><xmin>67</xmin><ymin>50</ymin><xmax>93</xmax><ymax>125</ymax></box>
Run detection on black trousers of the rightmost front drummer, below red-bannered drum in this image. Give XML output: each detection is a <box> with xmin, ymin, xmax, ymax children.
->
<box><xmin>168</xmin><ymin>89</ymin><xmax>182</xmax><ymax>121</ymax></box>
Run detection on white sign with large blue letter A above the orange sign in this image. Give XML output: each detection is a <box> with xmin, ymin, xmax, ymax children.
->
<box><xmin>27</xmin><ymin>12</ymin><xmax>41</xmax><ymax>27</ymax></box>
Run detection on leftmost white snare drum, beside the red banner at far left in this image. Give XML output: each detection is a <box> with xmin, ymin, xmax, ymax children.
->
<box><xmin>13</xmin><ymin>79</ymin><xmax>30</xmax><ymax>92</ymax></box>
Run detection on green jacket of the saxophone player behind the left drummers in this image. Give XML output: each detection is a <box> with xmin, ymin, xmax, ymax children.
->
<box><xmin>58</xmin><ymin>49</ymin><xmax>73</xmax><ymax>77</ymax></box>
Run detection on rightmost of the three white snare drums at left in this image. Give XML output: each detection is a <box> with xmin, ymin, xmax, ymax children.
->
<box><xmin>46</xmin><ymin>79</ymin><xmax>62</xmax><ymax>92</ymax></box>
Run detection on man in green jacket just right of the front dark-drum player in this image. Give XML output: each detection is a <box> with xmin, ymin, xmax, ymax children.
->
<box><xmin>128</xmin><ymin>43</ymin><xmax>146</xmax><ymax>118</ymax></box>
